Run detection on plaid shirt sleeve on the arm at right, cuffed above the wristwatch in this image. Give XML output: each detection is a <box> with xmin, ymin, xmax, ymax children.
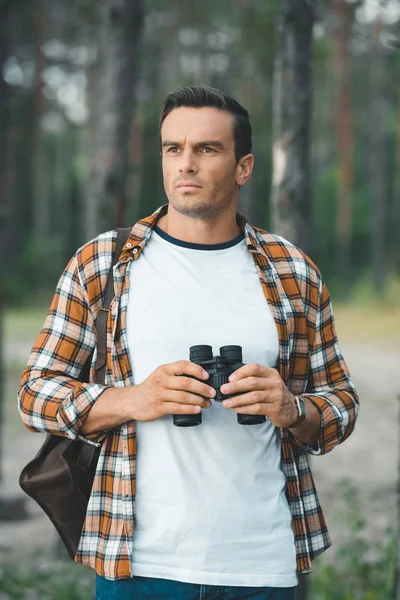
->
<box><xmin>289</xmin><ymin>280</ymin><xmax>359</xmax><ymax>455</ymax></box>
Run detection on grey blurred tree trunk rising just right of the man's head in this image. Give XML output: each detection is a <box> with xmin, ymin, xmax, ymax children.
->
<box><xmin>272</xmin><ymin>0</ymin><xmax>316</xmax><ymax>252</ymax></box>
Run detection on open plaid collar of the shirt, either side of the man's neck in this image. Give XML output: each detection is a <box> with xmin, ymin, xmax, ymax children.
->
<box><xmin>119</xmin><ymin>204</ymin><xmax>268</xmax><ymax>262</ymax></box>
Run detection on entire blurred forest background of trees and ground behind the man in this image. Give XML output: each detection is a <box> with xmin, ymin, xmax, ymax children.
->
<box><xmin>0</xmin><ymin>0</ymin><xmax>400</xmax><ymax>600</ymax></box>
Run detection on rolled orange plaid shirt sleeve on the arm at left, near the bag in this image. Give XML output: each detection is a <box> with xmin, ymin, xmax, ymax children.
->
<box><xmin>18</xmin><ymin>255</ymin><xmax>109</xmax><ymax>443</ymax></box>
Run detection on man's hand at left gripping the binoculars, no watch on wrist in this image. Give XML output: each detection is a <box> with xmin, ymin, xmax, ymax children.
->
<box><xmin>130</xmin><ymin>360</ymin><xmax>216</xmax><ymax>421</ymax></box>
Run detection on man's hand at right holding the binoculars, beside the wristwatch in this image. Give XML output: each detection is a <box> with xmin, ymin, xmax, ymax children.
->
<box><xmin>221</xmin><ymin>363</ymin><xmax>298</xmax><ymax>428</ymax></box>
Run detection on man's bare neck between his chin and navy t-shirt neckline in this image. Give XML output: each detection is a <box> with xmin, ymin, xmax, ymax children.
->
<box><xmin>157</xmin><ymin>204</ymin><xmax>241</xmax><ymax>244</ymax></box>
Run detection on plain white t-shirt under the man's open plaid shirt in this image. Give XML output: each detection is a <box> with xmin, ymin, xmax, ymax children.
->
<box><xmin>127</xmin><ymin>227</ymin><xmax>297</xmax><ymax>587</ymax></box>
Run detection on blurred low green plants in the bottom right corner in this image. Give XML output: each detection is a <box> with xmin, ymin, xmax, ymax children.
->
<box><xmin>310</xmin><ymin>482</ymin><xmax>397</xmax><ymax>600</ymax></box>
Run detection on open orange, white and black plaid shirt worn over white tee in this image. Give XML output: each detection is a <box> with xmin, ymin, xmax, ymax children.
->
<box><xmin>19</xmin><ymin>205</ymin><xmax>358</xmax><ymax>579</ymax></box>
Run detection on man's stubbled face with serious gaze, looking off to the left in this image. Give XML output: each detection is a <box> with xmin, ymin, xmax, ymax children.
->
<box><xmin>161</xmin><ymin>107</ymin><xmax>248</xmax><ymax>219</ymax></box>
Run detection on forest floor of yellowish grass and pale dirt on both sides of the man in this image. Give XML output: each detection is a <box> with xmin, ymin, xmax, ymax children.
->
<box><xmin>0</xmin><ymin>306</ymin><xmax>400</xmax><ymax>565</ymax></box>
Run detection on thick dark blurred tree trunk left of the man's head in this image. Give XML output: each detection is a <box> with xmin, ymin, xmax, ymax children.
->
<box><xmin>86</xmin><ymin>0</ymin><xmax>144</xmax><ymax>238</ymax></box>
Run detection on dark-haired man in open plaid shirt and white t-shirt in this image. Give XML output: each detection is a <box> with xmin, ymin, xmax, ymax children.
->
<box><xmin>19</xmin><ymin>86</ymin><xmax>358</xmax><ymax>600</ymax></box>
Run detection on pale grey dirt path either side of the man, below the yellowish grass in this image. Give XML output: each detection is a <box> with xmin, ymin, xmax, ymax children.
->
<box><xmin>0</xmin><ymin>342</ymin><xmax>400</xmax><ymax>562</ymax></box>
